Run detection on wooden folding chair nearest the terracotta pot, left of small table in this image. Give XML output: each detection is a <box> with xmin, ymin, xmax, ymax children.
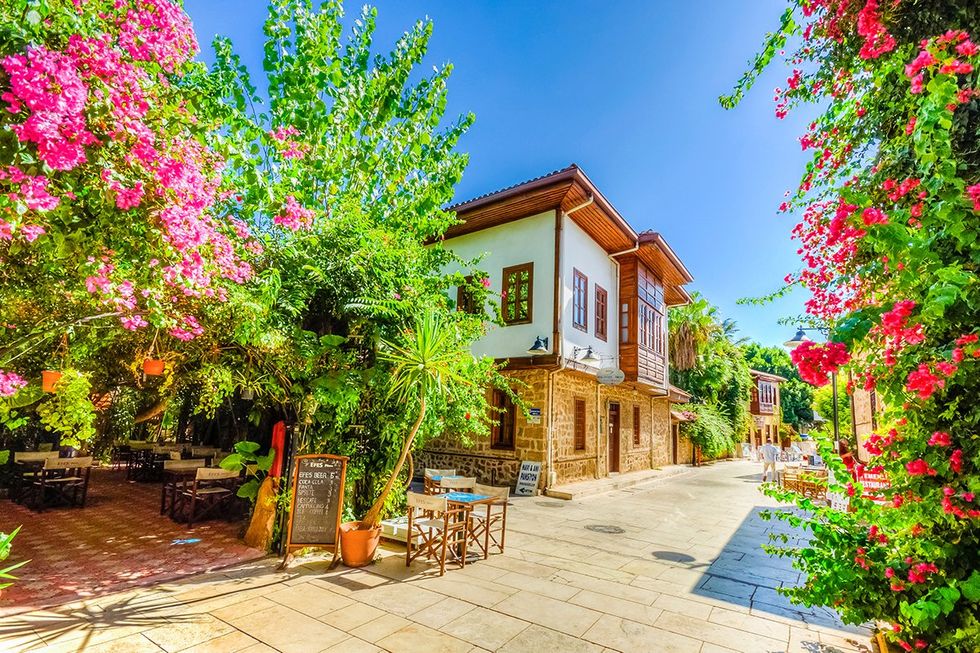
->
<box><xmin>405</xmin><ymin>492</ymin><xmax>471</xmax><ymax>576</ymax></box>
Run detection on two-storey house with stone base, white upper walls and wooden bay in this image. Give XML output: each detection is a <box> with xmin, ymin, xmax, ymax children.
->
<box><xmin>419</xmin><ymin>165</ymin><xmax>692</xmax><ymax>486</ymax></box>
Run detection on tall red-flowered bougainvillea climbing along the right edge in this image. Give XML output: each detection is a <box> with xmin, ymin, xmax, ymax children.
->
<box><xmin>722</xmin><ymin>0</ymin><xmax>980</xmax><ymax>652</ymax></box>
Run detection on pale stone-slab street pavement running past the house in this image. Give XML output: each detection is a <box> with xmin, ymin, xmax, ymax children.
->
<box><xmin>0</xmin><ymin>462</ymin><xmax>869</xmax><ymax>653</ymax></box>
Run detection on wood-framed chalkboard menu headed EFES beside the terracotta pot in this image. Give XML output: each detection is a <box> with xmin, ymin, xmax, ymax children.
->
<box><xmin>286</xmin><ymin>454</ymin><xmax>347</xmax><ymax>555</ymax></box>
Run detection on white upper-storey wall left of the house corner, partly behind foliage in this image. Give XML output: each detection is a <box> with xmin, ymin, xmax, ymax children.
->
<box><xmin>444</xmin><ymin>211</ymin><xmax>555</xmax><ymax>358</ymax></box>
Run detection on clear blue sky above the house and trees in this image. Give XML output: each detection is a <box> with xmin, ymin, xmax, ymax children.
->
<box><xmin>186</xmin><ymin>0</ymin><xmax>806</xmax><ymax>345</ymax></box>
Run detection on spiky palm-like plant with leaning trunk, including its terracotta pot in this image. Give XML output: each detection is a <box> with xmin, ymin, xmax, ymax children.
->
<box><xmin>340</xmin><ymin>313</ymin><xmax>473</xmax><ymax>567</ymax></box>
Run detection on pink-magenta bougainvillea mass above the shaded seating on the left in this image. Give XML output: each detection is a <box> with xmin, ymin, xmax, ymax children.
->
<box><xmin>0</xmin><ymin>0</ymin><xmax>259</xmax><ymax>444</ymax></box>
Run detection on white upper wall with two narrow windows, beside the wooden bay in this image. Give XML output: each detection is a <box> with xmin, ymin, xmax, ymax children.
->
<box><xmin>560</xmin><ymin>217</ymin><xmax>619</xmax><ymax>368</ymax></box>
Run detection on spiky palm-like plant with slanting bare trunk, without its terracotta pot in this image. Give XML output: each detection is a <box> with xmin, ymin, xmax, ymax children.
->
<box><xmin>362</xmin><ymin>312</ymin><xmax>472</xmax><ymax>528</ymax></box>
